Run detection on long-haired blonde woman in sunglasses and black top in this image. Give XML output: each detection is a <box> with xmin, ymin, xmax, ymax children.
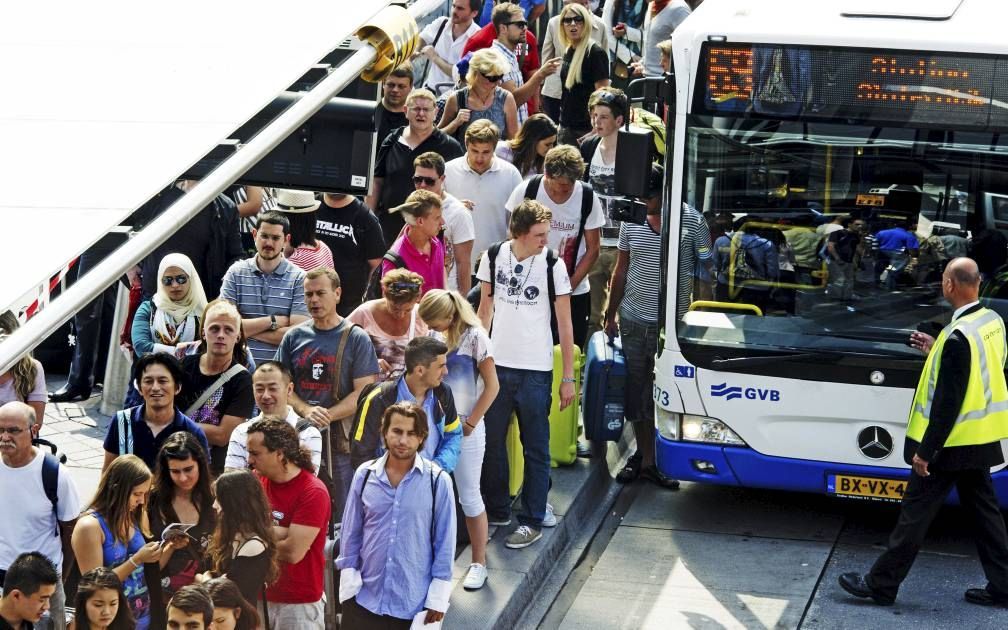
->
<box><xmin>559</xmin><ymin>3</ymin><xmax>609</xmax><ymax>145</ymax></box>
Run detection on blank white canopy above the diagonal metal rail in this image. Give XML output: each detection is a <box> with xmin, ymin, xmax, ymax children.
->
<box><xmin>0</xmin><ymin>0</ymin><xmax>388</xmax><ymax>309</ymax></box>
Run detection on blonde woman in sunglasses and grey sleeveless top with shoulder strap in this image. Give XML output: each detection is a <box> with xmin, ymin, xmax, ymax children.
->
<box><xmin>439</xmin><ymin>48</ymin><xmax>518</xmax><ymax>144</ymax></box>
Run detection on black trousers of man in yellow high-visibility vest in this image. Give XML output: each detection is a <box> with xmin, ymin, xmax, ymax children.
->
<box><xmin>867</xmin><ymin>469</ymin><xmax>1008</xmax><ymax>599</ymax></box>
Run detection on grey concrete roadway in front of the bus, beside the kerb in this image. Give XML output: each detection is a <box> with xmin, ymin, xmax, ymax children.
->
<box><xmin>559</xmin><ymin>484</ymin><xmax>1008</xmax><ymax>630</ymax></box>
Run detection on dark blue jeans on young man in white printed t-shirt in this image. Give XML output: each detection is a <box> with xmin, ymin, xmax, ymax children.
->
<box><xmin>480</xmin><ymin>366</ymin><xmax>553</xmax><ymax>529</ymax></box>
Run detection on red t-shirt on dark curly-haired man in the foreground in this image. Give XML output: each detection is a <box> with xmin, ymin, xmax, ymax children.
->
<box><xmin>259</xmin><ymin>471</ymin><xmax>330</xmax><ymax>604</ymax></box>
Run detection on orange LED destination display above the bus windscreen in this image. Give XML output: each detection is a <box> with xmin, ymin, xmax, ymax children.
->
<box><xmin>695</xmin><ymin>42</ymin><xmax>1008</xmax><ymax>128</ymax></box>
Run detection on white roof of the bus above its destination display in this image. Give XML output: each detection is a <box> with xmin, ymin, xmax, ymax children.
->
<box><xmin>673</xmin><ymin>0</ymin><xmax>1008</xmax><ymax>53</ymax></box>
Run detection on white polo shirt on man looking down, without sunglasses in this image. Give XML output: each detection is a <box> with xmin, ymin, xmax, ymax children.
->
<box><xmin>445</xmin><ymin>155</ymin><xmax>521</xmax><ymax>274</ymax></box>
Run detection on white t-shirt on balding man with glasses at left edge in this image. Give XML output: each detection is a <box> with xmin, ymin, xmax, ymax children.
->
<box><xmin>0</xmin><ymin>449</ymin><xmax>81</xmax><ymax>570</ymax></box>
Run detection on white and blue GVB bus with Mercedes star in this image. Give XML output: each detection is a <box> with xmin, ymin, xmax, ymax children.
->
<box><xmin>654</xmin><ymin>0</ymin><xmax>1008</xmax><ymax>502</ymax></box>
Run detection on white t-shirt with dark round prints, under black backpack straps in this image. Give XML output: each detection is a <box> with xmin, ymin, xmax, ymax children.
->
<box><xmin>476</xmin><ymin>241</ymin><xmax>571</xmax><ymax>372</ymax></box>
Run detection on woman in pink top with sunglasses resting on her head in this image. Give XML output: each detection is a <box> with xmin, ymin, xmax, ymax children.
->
<box><xmin>347</xmin><ymin>269</ymin><xmax>427</xmax><ymax>382</ymax></box>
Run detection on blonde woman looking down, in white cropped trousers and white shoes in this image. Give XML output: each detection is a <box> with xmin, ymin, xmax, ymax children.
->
<box><xmin>419</xmin><ymin>289</ymin><xmax>500</xmax><ymax>591</ymax></box>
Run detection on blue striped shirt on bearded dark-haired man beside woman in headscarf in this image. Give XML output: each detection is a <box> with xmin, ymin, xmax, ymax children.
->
<box><xmin>221</xmin><ymin>256</ymin><xmax>308</xmax><ymax>364</ymax></box>
